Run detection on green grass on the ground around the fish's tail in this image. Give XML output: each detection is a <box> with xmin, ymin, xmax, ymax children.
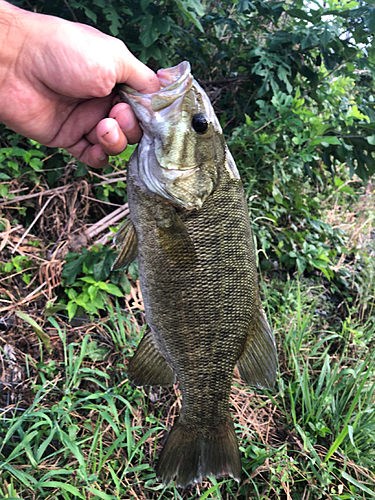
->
<box><xmin>0</xmin><ymin>280</ymin><xmax>375</xmax><ymax>500</ymax></box>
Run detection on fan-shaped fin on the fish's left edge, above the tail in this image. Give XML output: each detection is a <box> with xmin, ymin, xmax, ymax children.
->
<box><xmin>128</xmin><ymin>328</ymin><xmax>176</xmax><ymax>386</ymax></box>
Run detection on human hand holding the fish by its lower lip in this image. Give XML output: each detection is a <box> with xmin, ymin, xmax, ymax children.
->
<box><xmin>0</xmin><ymin>0</ymin><xmax>160</xmax><ymax>168</ymax></box>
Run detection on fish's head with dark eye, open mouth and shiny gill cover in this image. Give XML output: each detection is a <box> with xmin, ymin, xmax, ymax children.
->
<box><xmin>119</xmin><ymin>61</ymin><xmax>228</xmax><ymax>210</ymax></box>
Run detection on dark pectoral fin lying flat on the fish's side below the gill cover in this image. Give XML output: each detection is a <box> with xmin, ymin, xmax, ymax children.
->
<box><xmin>155</xmin><ymin>209</ymin><xmax>196</xmax><ymax>265</ymax></box>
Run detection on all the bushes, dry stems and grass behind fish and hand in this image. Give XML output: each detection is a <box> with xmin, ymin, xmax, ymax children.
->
<box><xmin>0</xmin><ymin>0</ymin><xmax>375</xmax><ymax>500</ymax></box>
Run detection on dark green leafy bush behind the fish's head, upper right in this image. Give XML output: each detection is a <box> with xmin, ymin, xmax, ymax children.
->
<box><xmin>9</xmin><ymin>0</ymin><xmax>375</xmax><ymax>279</ymax></box>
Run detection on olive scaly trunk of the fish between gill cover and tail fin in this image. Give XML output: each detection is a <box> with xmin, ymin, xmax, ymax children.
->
<box><xmin>128</xmin><ymin>159</ymin><xmax>257</xmax><ymax>406</ymax></box>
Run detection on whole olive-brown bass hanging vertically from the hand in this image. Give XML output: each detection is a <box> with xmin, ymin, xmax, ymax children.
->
<box><xmin>113</xmin><ymin>61</ymin><xmax>278</xmax><ymax>487</ymax></box>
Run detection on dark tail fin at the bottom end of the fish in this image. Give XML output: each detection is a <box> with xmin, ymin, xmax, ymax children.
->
<box><xmin>156</xmin><ymin>417</ymin><xmax>241</xmax><ymax>487</ymax></box>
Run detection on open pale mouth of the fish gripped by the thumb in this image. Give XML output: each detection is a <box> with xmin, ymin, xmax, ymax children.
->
<box><xmin>118</xmin><ymin>61</ymin><xmax>193</xmax><ymax>112</ymax></box>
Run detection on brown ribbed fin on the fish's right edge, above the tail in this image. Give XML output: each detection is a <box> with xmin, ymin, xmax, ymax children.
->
<box><xmin>238</xmin><ymin>304</ymin><xmax>277</xmax><ymax>388</ymax></box>
